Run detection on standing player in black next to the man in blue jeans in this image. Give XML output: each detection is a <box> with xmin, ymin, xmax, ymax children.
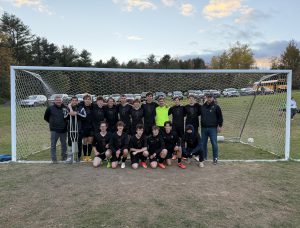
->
<box><xmin>184</xmin><ymin>95</ymin><xmax>201</xmax><ymax>132</ymax></box>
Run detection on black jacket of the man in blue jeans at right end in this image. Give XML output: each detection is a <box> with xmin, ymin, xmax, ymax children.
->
<box><xmin>201</xmin><ymin>102</ymin><xmax>223</xmax><ymax>127</ymax></box>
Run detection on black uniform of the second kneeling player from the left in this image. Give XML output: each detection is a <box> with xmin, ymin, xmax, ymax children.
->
<box><xmin>109</xmin><ymin>132</ymin><xmax>129</xmax><ymax>162</ymax></box>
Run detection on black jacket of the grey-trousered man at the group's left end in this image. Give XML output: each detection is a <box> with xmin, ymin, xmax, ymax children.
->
<box><xmin>44</xmin><ymin>105</ymin><xmax>68</xmax><ymax>133</ymax></box>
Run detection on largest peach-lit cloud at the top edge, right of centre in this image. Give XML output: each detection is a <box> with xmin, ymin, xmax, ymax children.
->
<box><xmin>203</xmin><ymin>0</ymin><xmax>242</xmax><ymax>20</ymax></box>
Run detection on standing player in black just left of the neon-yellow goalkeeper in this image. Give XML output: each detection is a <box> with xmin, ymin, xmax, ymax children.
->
<box><xmin>142</xmin><ymin>92</ymin><xmax>158</xmax><ymax>136</ymax></box>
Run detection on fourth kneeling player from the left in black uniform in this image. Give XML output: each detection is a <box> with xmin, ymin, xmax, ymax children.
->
<box><xmin>147</xmin><ymin>125</ymin><xmax>168</xmax><ymax>169</ymax></box>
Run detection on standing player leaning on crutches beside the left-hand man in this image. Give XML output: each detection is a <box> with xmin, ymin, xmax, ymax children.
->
<box><xmin>66</xmin><ymin>96</ymin><xmax>86</xmax><ymax>163</ymax></box>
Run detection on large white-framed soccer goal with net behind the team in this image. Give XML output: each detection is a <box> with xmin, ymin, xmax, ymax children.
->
<box><xmin>11</xmin><ymin>66</ymin><xmax>292</xmax><ymax>161</ymax></box>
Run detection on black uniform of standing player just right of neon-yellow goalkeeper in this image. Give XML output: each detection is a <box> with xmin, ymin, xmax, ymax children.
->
<box><xmin>169</xmin><ymin>105</ymin><xmax>186</xmax><ymax>138</ymax></box>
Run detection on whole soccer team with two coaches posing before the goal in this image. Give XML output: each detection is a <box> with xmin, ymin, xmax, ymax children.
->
<box><xmin>44</xmin><ymin>92</ymin><xmax>223</xmax><ymax>169</ymax></box>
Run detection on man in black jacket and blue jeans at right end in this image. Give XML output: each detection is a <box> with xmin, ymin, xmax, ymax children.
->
<box><xmin>201</xmin><ymin>94</ymin><xmax>223</xmax><ymax>165</ymax></box>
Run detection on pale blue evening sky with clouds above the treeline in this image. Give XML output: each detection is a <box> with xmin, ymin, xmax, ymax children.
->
<box><xmin>0</xmin><ymin>0</ymin><xmax>300</xmax><ymax>68</ymax></box>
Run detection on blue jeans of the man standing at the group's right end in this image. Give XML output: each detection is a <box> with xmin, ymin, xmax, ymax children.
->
<box><xmin>201</xmin><ymin>127</ymin><xmax>219</xmax><ymax>160</ymax></box>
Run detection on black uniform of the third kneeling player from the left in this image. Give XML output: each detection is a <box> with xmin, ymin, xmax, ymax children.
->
<box><xmin>129</xmin><ymin>135</ymin><xmax>147</xmax><ymax>164</ymax></box>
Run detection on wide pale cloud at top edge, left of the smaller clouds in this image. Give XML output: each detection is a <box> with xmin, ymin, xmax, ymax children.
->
<box><xmin>113</xmin><ymin>0</ymin><xmax>157</xmax><ymax>12</ymax></box>
